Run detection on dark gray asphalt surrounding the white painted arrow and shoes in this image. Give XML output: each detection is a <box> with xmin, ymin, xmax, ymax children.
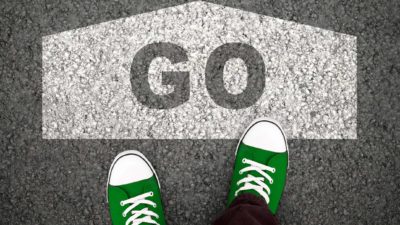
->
<box><xmin>0</xmin><ymin>0</ymin><xmax>400</xmax><ymax>225</ymax></box>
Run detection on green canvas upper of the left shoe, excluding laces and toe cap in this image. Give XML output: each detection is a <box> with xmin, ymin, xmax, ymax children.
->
<box><xmin>108</xmin><ymin>175</ymin><xmax>165</xmax><ymax>225</ymax></box>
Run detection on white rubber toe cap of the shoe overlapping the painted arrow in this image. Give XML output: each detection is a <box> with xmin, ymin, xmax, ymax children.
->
<box><xmin>243</xmin><ymin>120</ymin><xmax>287</xmax><ymax>152</ymax></box>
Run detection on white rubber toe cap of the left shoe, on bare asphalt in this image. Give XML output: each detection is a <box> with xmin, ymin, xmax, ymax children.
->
<box><xmin>109</xmin><ymin>151</ymin><xmax>153</xmax><ymax>186</ymax></box>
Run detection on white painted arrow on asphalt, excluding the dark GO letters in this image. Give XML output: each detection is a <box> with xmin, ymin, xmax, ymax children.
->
<box><xmin>42</xmin><ymin>2</ymin><xmax>357</xmax><ymax>139</ymax></box>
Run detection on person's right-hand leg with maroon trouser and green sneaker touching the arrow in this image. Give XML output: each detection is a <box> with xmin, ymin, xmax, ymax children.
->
<box><xmin>214</xmin><ymin>119</ymin><xmax>289</xmax><ymax>225</ymax></box>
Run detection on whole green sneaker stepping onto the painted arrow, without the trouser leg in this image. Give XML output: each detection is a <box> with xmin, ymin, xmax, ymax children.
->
<box><xmin>228</xmin><ymin>119</ymin><xmax>289</xmax><ymax>215</ymax></box>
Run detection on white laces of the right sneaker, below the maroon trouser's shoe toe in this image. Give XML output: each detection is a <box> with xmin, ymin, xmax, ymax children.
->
<box><xmin>235</xmin><ymin>159</ymin><xmax>276</xmax><ymax>204</ymax></box>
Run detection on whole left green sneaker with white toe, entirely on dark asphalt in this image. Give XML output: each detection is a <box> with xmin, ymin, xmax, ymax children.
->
<box><xmin>107</xmin><ymin>150</ymin><xmax>165</xmax><ymax>225</ymax></box>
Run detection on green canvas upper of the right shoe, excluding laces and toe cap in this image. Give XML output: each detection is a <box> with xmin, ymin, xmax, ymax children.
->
<box><xmin>228</xmin><ymin>142</ymin><xmax>288</xmax><ymax>214</ymax></box>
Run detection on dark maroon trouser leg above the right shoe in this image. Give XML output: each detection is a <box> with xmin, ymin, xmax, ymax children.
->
<box><xmin>213</xmin><ymin>194</ymin><xmax>278</xmax><ymax>225</ymax></box>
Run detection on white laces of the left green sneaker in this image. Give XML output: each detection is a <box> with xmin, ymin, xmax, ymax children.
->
<box><xmin>121</xmin><ymin>192</ymin><xmax>159</xmax><ymax>225</ymax></box>
